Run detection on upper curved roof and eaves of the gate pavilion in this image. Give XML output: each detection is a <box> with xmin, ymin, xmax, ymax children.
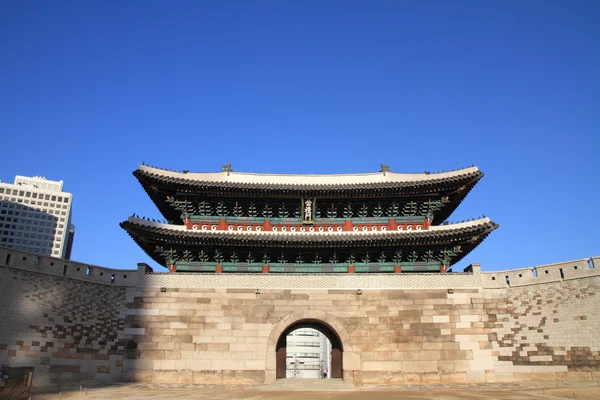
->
<box><xmin>133</xmin><ymin>166</ymin><xmax>483</xmax><ymax>223</ymax></box>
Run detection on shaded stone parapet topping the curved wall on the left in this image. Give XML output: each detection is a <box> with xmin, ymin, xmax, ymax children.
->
<box><xmin>0</xmin><ymin>247</ymin><xmax>137</xmax><ymax>287</ymax></box>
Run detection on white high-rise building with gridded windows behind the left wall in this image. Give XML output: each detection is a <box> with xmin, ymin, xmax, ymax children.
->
<box><xmin>0</xmin><ymin>175</ymin><xmax>75</xmax><ymax>259</ymax></box>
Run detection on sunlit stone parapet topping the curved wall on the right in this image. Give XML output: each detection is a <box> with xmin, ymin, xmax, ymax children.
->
<box><xmin>481</xmin><ymin>257</ymin><xmax>600</xmax><ymax>289</ymax></box>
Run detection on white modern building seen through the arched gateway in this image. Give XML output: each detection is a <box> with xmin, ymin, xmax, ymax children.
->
<box><xmin>286</xmin><ymin>328</ymin><xmax>331</xmax><ymax>379</ymax></box>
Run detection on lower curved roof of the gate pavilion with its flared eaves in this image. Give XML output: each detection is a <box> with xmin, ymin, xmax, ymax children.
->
<box><xmin>120</xmin><ymin>217</ymin><xmax>498</xmax><ymax>265</ymax></box>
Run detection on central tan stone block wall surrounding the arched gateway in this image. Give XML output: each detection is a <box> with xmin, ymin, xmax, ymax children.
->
<box><xmin>124</xmin><ymin>288</ymin><xmax>490</xmax><ymax>383</ymax></box>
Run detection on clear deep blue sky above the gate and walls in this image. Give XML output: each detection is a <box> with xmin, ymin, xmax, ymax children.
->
<box><xmin>0</xmin><ymin>0</ymin><xmax>600</xmax><ymax>271</ymax></box>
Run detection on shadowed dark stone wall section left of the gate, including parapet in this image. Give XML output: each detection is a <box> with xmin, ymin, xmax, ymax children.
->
<box><xmin>0</xmin><ymin>248</ymin><xmax>135</xmax><ymax>386</ymax></box>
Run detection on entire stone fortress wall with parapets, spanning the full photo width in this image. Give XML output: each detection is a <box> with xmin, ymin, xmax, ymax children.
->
<box><xmin>0</xmin><ymin>248</ymin><xmax>600</xmax><ymax>386</ymax></box>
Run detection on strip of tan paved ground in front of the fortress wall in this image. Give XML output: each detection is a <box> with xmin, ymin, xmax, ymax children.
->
<box><xmin>27</xmin><ymin>380</ymin><xmax>600</xmax><ymax>400</ymax></box>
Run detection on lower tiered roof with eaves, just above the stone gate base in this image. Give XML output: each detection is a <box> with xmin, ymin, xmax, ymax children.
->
<box><xmin>121</xmin><ymin>217</ymin><xmax>498</xmax><ymax>266</ymax></box>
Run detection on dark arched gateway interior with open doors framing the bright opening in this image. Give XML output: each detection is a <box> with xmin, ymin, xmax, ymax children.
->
<box><xmin>275</xmin><ymin>319</ymin><xmax>344</xmax><ymax>379</ymax></box>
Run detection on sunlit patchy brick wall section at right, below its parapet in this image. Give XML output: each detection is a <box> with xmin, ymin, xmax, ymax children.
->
<box><xmin>483</xmin><ymin>276</ymin><xmax>600</xmax><ymax>381</ymax></box>
